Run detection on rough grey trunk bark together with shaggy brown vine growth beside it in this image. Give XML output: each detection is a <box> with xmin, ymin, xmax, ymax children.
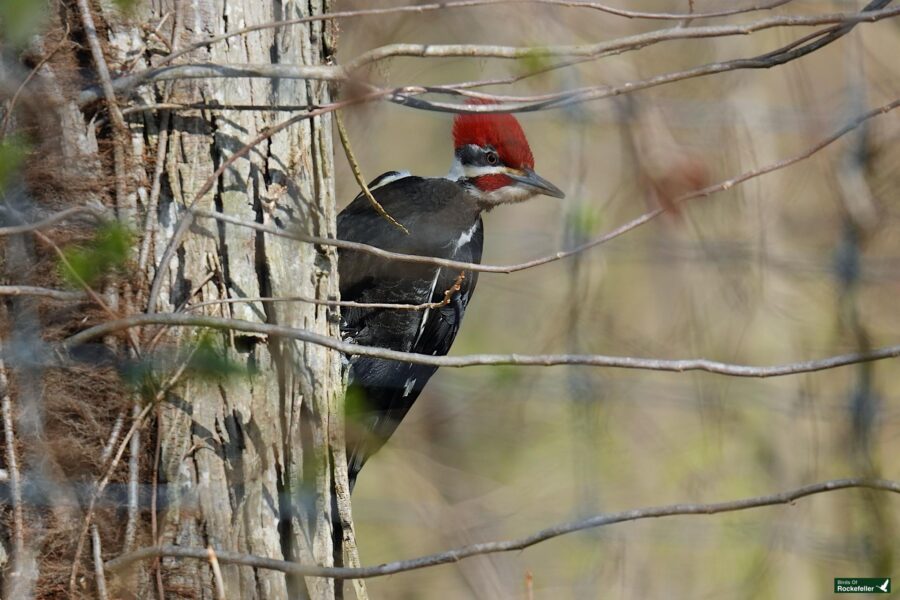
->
<box><xmin>0</xmin><ymin>0</ymin><xmax>342</xmax><ymax>599</ymax></box>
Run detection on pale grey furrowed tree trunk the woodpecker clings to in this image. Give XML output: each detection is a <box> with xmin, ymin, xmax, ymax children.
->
<box><xmin>109</xmin><ymin>0</ymin><xmax>341</xmax><ymax>599</ymax></box>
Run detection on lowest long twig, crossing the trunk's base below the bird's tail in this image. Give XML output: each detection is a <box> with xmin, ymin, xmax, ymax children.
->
<box><xmin>106</xmin><ymin>478</ymin><xmax>900</xmax><ymax>579</ymax></box>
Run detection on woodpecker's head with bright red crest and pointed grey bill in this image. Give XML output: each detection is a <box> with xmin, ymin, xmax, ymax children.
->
<box><xmin>448</xmin><ymin>102</ymin><xmax>565</xmax><ymax>210</ymax></box>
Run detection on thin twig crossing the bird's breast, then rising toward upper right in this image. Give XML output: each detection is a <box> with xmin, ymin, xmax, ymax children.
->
<box><xmin>185</xmin><ymin>99</ymin><xmax>900</xmax><ymax>273</ymax></box>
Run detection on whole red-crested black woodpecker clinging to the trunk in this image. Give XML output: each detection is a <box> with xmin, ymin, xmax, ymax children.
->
<box><xmin>337</xmin><ymin>113</ymin><xmax>564</xmax><ymax>490</ymax></box>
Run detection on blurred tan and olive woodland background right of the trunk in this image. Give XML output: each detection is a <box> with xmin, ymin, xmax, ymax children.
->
<box><xmin>335</xmin><ymin>0</ymin><xmax>900</xmax><ymax>600</ymax></box>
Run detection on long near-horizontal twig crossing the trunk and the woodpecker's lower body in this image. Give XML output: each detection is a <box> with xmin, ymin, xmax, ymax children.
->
<box><xmin>60</xmin><ymin>313</ymin><xmax>900</xmax><ymax>378</ymax></box>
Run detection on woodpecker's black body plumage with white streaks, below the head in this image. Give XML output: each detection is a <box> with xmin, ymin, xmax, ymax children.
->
<box><xmin>337</xmin><ymin>173</ymin><xmax>483</xmax><ymax>489</ymax></box>
